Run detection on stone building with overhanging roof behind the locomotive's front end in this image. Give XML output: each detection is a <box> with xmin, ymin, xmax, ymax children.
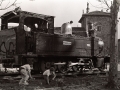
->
<box><xmin>79</xmin><ymin>5</ymin><xmax>111</xmax><ymax>55</ymax></box>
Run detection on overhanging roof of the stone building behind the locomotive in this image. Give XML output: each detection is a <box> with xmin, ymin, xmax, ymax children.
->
<box><xmin>79</xmin><ymin>11</ymin><xmax>110</xmax><ymax>23</ymax></box>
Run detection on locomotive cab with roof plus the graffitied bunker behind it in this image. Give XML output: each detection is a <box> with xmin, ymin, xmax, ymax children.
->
<box><xmin>0</xmin><ymin>8</ymin><xmax>54</xmax><ymax>68</ymax></box>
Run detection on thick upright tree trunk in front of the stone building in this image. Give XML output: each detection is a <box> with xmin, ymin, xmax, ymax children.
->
<box><xmin>108</xmin><ymin>0</ymin><xmax>119</xmax><ymax>89</ymax></box>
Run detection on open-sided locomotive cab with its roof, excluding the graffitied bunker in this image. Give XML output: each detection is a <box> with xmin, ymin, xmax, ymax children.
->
<box><xmin>1</xmin><ymin>10</ymin><xmax>54</xmax><ymax>54</ymax></box>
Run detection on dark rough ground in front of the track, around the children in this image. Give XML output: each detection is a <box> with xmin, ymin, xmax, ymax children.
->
<box><xmin>0</xmin><ymin>64</ymin><xmax>120</xmax><ymax>90</ymax></box>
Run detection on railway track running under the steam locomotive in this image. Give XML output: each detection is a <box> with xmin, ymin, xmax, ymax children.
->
<box><xmin>0</xmin><ymin>71</ymin><xmax>107</xmax><ymax>80</ymax></box>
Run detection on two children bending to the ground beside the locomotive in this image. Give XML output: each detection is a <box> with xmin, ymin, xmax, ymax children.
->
<box><xmin>19</xmin><ymin>63</ymin><xmax>56</xmax><ymax>85</ymax></box>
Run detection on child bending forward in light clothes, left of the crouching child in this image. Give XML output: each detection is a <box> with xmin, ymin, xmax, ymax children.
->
<box><xmin>19</xmin><ymin>62</ymin><xmax>32</xmax><ymax>85</ymax></box>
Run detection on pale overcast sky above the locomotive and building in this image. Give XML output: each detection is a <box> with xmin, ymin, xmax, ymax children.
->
<box><xmin>0</xmin><ymin>0</ymin><xmax>120</xmax><ymax>38</ymax></box>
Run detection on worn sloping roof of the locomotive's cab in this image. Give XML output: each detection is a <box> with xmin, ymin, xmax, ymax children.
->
<box><xmin>1</xmin><ymin>10</ymin><xmax>54</xmax><ymax>23</ymax></box>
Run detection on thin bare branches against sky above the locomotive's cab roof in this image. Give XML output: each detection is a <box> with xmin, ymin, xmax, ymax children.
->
<box><xmin>0</xmin><ymin>0</ymin><xmax>17</xmax><ymax>10</ymax></box>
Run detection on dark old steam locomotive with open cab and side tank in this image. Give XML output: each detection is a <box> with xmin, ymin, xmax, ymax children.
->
<box><xmin>0</xmin><ymin>9</ymin><xmax>108</xmax><ymax>72</ymax></box>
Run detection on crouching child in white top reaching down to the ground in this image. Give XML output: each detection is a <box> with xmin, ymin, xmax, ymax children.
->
<box><xmin>43</xmin><ymin>67</ymin><xmax>56</xmax><ymax>85</ymax></box>
